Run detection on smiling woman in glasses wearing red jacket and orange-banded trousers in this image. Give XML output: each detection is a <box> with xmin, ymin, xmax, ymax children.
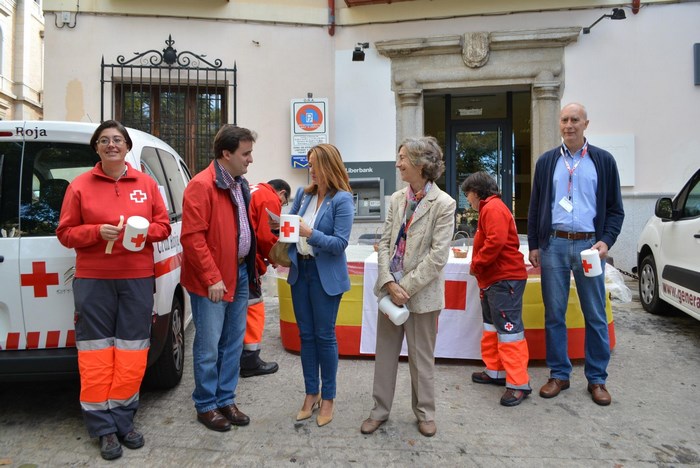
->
<box><xmin>56</xmin><ymin>120</ymin><xmax>170</xmax><ymax>460</ymax></box>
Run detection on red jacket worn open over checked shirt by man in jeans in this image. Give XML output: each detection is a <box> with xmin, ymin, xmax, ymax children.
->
<box><xmin>180</xmin><ymin>161</ymin><xmax>256</xmax><ymax>302</ymax></box>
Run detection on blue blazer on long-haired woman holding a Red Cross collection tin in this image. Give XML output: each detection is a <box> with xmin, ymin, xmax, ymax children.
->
<box><xmin>287</xmin><ymin>188</ymin><xmax>355</xmax><ymax>296</ymax></box>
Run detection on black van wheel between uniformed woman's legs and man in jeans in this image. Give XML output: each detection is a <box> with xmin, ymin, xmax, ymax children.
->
<box><xmin>144</xmin><ymin>296</ymin><xmax>185</xmax><ymax>390</ymax></box>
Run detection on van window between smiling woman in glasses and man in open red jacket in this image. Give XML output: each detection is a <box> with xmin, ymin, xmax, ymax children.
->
<box><xmin>141</xmin><ymin>146</ymin><xmax>185</xmax><ymax>220</ymax></box>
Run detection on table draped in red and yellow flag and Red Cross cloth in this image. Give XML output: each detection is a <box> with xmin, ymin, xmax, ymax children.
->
<box><xmin>277</xmin><ymin>245</ymin><xmax>615</xmax><ymax>359</ymax></box>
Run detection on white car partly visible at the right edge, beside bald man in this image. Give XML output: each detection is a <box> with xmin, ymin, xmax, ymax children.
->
<box><xmin>637</xmin><ymin>169</ymin><xmax>700</xmax><ymax>320</ymax></box>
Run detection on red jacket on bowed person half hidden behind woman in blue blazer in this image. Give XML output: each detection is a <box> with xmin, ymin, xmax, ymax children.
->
<box><xmin>248</xmin><ymin>183</ymin><xmax>282</xmax><ymax>276</ymax></box>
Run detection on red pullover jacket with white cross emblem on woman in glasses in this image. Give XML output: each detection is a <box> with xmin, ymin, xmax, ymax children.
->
<box><xmin>56</xmin><ymin>162</ymin><xmax>170</xmax><ymax>279</ymax></box>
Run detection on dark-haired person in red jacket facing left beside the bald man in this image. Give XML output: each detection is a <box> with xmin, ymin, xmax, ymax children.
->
<box><xmin>461</xmin><ymin>171</ymin><xmax>532</xmax><ymax>406</ymax></box>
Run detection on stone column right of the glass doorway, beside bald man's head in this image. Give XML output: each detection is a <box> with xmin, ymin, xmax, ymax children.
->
<box><xmin>532</xmin><ymin>71</ymin><xmax>561</xmax><ymax>166</ymax></box>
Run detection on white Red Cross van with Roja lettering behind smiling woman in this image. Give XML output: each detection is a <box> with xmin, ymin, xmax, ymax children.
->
<box><xmin>0</xmin><ymin>121</ymin><xmax>191</xmax><ymax>388</ymax></box>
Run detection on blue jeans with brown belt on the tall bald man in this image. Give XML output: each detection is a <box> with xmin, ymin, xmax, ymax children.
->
<box><xmin>540</xmin><ymin>236</ymin><xmax>610</xmax><ymax>384</ymax></box>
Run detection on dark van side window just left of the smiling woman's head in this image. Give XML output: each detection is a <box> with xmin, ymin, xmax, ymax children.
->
<box><xmin>15</xmin><ymin>142</ymin><xmax>100</xmax><ymax>237</ymax></box>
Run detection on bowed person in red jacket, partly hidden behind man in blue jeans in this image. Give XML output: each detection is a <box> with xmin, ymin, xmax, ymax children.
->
<box><xmin>241</xmin><ymin>179</ymin><xmax>291</xmax><ymax>377</ymax></box>
